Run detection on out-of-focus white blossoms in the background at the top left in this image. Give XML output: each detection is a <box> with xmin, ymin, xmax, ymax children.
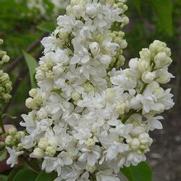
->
<box><xmin>27</xmin><ymin>0</ymin><xmax>69</xmax><ymax>17</ymax></box>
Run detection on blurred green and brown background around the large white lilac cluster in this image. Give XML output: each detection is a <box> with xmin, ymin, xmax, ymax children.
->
<box><xmin>0</xmin><ymin>0</ymin><xmax>181</xmax><ymax>181</ymax></box>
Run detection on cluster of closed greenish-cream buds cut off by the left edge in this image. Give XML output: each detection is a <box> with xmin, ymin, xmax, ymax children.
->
<box><xmin>0</xmin><ymin>39</ymin><xmax>12</xmax><ymax>109</ymax></box>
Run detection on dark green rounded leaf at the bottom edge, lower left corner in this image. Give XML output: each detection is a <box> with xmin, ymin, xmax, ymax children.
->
<box><xmin>12</xmin><ymin>168</ymin><xmax>37</xmax><ymax>181</ymax></box>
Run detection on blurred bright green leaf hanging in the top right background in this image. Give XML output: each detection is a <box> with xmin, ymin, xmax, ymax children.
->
<box><xmin>151</xmin><ymin>0</ymin><xmax>173</xmax><ymax>36</ymax></box>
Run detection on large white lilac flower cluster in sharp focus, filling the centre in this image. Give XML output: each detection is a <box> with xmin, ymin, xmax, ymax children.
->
<box><xmin>6</xmin><ymin>0</ymin><xmax>174</xmax><ymax>181</ymax></box>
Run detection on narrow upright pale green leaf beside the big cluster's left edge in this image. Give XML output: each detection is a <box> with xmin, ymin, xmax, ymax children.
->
<box><xmin>23</xmin><ymin>51</ymin><xmax>37</xmax><ymax>88</ymax></box>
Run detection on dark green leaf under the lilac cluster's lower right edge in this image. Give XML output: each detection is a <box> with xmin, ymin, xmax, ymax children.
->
<box><xmin>121</xmin><ymin>162</ymin><xmax>152</xmax><ymax>181</ymax></box>
